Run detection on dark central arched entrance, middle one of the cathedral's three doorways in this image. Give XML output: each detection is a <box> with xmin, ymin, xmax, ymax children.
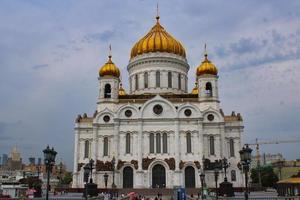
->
<box><xmin>152</xmin><ymin>164</ymin><xmax>166</xmax><ymax>188</ymax></box>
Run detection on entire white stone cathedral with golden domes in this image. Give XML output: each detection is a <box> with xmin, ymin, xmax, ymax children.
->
<box><xmin>72</xmin><ymin>16</ymin><xmax>244</xmax><ymax>188</ymax></box>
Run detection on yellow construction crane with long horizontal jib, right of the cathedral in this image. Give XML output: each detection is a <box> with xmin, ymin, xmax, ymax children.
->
<box><xmin>247</xmin><ymin>138</ymin><xmax>300</xmax><ymax>186</ymax></box>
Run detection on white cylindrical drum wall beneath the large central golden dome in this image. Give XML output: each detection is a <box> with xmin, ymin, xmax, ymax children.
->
<box><xmin>127</xmin><ymin>53</ymin><xmax>189</xmax><ymax>94</ymax></box>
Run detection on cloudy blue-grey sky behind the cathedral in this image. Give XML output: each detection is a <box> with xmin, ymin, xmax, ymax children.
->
<box><xmin>0</xmin><ymin>0</ymin><xmax>300</xmax><ymax>169</ymax></box>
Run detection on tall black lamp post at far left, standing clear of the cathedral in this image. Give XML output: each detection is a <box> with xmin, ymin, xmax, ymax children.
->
<box><xmin>43</xmin><ymin>146</ymin><xmax>57</xmax><ymax>200</ymax></box>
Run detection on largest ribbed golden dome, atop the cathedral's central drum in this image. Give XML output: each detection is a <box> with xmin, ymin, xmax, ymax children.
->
<box><xmin>130</xmin><ymin>16</ymin><xmax>186</xmax><ymax>58</ymax></box>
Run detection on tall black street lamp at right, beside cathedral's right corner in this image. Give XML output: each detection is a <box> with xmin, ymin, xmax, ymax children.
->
<box><xmin>239</xmin><ymin>144</ymin><xmax>252</xmax><ymax>200</ymax></box>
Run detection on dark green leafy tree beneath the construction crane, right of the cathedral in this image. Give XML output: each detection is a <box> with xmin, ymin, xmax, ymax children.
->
<box><xmin>251</xmin><ymin>166</ymin><xmax>278</xmax><ymax>187</ymax></box>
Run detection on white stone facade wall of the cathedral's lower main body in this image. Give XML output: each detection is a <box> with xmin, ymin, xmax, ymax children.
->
<box><xmin>73</xmin><ymin>96</ymin><xmax>243</xmax><ymax>188</ymax></box>
